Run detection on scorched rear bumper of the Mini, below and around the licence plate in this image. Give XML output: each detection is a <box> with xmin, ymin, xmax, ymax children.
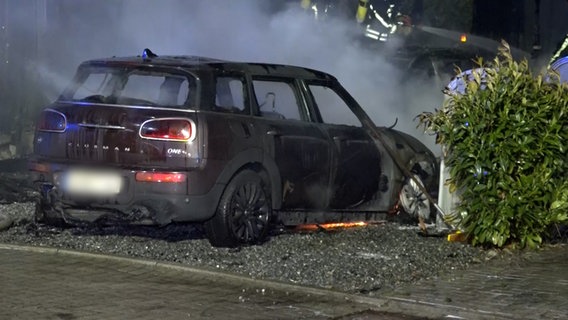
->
<box><xmin>31</xmin><ymin>166</ymin><xmax>224</xmax><ymax>225</ymax></box>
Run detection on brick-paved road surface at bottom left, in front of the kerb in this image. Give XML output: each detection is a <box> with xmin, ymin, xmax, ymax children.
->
<box><xmin>0</xmin><ymin>246</ymin><xmax>378</xmax><ymax>320</ymax></box>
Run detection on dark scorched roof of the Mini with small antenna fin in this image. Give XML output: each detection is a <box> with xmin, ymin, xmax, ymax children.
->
<box><xmin>81</xmin><ymin>55</ymin><xmax>337</xmax><ymax>81</ymax></box>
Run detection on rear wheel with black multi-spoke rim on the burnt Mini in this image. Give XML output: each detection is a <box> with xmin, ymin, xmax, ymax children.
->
<box><xmin>204</xmin><ymin>169</ymin><xmax>272</xmax><ymax>247</ymax></box>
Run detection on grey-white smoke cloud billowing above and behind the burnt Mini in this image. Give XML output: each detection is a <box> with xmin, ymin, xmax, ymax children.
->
<box><xmin>1</xmin><ymin>0</ymin><xmax>442</xmax><ymax>152</ymax></box>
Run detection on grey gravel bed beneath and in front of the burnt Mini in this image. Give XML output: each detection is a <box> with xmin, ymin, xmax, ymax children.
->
<box><xmin>0</xmin><ymin>168</ymin><xmax>540</xmax><ymax>296</ymax></box>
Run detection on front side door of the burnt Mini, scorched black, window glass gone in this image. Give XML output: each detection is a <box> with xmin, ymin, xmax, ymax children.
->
<box><xmin>305</xmin><ymin>81</ymin><xmax>381</xmax><ymax>209</ymax></box>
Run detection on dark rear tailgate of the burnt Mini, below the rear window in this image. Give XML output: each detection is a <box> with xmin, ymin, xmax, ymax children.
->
<box><xmin>34</xmin><ymin>103</ymin><xmax>203</xmax><ymax>170</ymax></box>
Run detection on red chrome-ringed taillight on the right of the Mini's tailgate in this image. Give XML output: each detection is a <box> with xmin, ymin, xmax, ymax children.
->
<box><xmin>140</xmin><ymin>118</ymin><xmax>195</xmax><ymax>141</ymax></box>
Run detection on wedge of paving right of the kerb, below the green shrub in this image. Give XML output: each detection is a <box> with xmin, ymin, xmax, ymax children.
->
<box><xmin>384</xmin><ymin>245</ymin><xmax>568</xmax><ymax>319</ymax></box>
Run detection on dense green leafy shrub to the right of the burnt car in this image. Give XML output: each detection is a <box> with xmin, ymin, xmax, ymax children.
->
<box><xmin>418</xmin><ymin>43</ymin><xmax>568</xmax><ymax>247</ymax></box>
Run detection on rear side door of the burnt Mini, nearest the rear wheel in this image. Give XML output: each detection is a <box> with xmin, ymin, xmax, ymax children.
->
<box><xmin>252</xmin><ymin>76</ymin><xmax>332</xmax><ymax>209</ymax></box>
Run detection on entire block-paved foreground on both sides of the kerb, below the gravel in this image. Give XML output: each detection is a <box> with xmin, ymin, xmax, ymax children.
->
<box><xmin>0</xmin><ymin>244</ymin><xmax>568</xmax><ymax>320</ymax></box>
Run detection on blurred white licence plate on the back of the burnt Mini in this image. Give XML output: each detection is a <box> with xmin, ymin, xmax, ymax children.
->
<box><xmin>64</xmin><ymin>171</ymin><xmax>122</xmax><ymax>195</ymax></box>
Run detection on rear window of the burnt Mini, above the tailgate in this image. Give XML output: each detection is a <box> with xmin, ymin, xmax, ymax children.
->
<box><xmin>60</xmin><ymin>67</ymin><xmax>197</xmax><ymax>109</ymax></box>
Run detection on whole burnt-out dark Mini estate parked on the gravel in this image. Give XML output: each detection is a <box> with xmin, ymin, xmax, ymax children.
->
<box><xmin>30</xmin><ymin>50</ymin><xmax>438</xmax><ymax>246</ymax></box>
